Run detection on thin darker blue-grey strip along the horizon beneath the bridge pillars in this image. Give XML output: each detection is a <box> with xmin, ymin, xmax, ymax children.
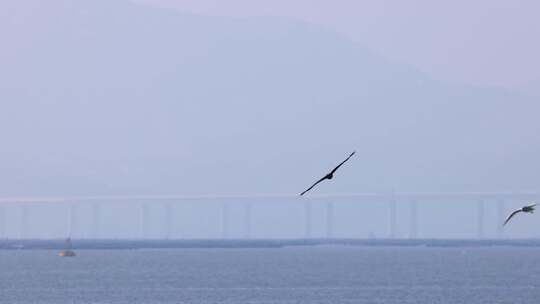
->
<box><xmin>5</xmin><ymin>238</ymin><xmax>540</xmax><ymax>250</ymax></box>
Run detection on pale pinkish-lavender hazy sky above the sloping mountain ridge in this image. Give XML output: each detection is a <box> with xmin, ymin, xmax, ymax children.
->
<box><xmin>138</xmin><ymin>0</ymin><xmax>540</xmax><ymax>87</ymax></box>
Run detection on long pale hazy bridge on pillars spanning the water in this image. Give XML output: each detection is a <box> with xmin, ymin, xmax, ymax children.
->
<box><xmin>0</xmin><ymin>191</ymin><xmax>540</xmax><ymax>239</ymax></box>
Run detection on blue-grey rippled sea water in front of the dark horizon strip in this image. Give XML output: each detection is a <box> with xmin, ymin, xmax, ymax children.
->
<box><xmin>0</xmin><ymin>247</ymin><xmax>540</xmax><ymax>304</ymax></box>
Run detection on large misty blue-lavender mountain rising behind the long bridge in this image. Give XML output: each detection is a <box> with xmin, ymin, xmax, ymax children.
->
<box><xmin>0</xmin><ymin>0</ymin><xmax>540</xmax><ymax>196</ymax></box>
